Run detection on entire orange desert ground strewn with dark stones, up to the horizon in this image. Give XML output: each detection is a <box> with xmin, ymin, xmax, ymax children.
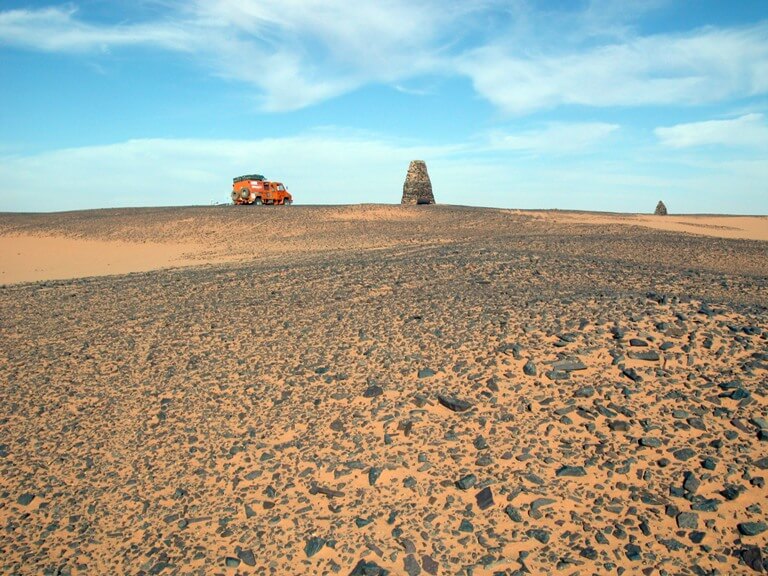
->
<box><xmin>0</xmin><ymin>205</ymin><xmax>768</xmax><ymax>576</ymax></box>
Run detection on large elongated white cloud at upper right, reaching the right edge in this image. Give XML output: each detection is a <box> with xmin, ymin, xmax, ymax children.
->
<box><xmin>458</xmin><ymin>23</ymin><xmax>768</xmax><ymax>114</ymax></box>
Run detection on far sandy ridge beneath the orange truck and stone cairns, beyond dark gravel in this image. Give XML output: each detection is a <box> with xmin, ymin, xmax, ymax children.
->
<box><xmin>0</xmin><ymin>204</ymin><xmax>768</xmax><ymax>284</ymax></box>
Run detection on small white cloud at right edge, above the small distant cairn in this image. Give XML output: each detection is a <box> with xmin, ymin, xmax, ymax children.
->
<box><xmin>654</xmin><ymin>113</ymin><xmax>768</xmax><ymax>148</ymax></box>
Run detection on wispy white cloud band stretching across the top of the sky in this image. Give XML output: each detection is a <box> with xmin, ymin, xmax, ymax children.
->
<box><xmin>0</xmin><ymin>0</ymin><xmax>768</xmax><ymax>115</ymax></box>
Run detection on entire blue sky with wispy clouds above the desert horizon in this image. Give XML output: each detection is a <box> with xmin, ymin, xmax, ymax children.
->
<box><xmin>0</xmin><ymin>0</ymin><xmax>768</xmax><ymax>214</ymax></box>
